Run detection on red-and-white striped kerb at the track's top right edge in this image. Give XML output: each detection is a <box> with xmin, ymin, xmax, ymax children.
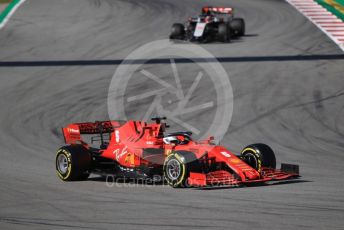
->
<box><xmin>286</xmin><ymin>0</ymin><xmax>344</xmax><ymax>51</ymax></box>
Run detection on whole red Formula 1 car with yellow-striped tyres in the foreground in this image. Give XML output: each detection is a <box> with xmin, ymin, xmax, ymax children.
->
<box><xmin>56</xmin><ymin>117</ymin><xmax>299</xmax><ymax>188</ymax></box>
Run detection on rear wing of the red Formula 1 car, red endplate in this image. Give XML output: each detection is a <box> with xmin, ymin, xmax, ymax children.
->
<box><xmin>62</xmin><ymin>121</ymin><xmax>122</xmax><ymax>144</ymax></box>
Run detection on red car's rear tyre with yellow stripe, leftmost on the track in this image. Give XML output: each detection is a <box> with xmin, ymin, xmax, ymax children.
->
<box><xmin>55</xmin><ymin>145</ymin><xmax>92</xmax><ymax>181</ymax></box>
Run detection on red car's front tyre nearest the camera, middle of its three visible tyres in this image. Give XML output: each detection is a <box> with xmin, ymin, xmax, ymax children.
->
<box><xmin>163</xmin><ymin>151</ymin><xmax>200</xmax><ymax>188</ymax></box>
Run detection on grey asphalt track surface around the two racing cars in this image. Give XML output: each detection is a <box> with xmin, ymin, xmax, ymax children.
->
<box><xmin>0</xmin><ymin>0</ymin><xmax>344</xmax><ymax>229</ymax></box>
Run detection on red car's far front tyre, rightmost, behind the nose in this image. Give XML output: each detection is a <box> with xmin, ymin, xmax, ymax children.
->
<box><xmin>241</xmin><ymin>143</ymin><xmax>276</xmax><ymax>172</ymax></box>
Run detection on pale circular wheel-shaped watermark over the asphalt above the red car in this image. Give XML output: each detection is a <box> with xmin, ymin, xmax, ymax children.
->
<box><xmin>108</xmin><ymin>40</ymin><xmax>233</xmax><ymax>141</ymax></box>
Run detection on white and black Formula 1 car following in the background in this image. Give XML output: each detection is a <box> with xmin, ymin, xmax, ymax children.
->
<box><xmin>170</xmin><ymin>7</ymin><xmax>245</xmax><ymax>42</ymax></box>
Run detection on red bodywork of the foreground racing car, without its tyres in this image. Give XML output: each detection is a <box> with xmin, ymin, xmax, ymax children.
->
<box><xmin>63</xmin><ymin>120</ymin><xmax>298</xmax><ymax>186</ymax></box>
